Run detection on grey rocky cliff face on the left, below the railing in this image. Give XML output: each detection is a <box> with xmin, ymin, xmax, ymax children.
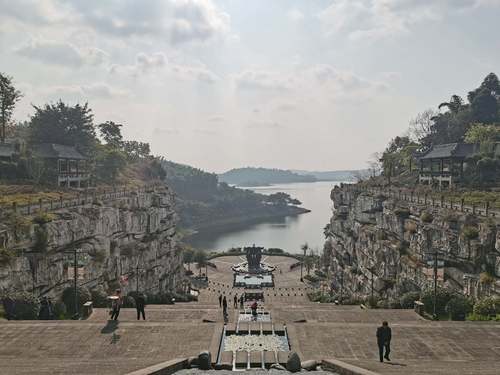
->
<box><xmin>0</xmin><ymin>186</ymin><xmax>183</xmax><ymax>296</ymax></box>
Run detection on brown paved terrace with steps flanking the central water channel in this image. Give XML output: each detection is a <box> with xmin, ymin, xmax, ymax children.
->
<box><xmin>0</xmin><ymin>257</ymin><xmax>500</xmax><ymax>375</ymax></box>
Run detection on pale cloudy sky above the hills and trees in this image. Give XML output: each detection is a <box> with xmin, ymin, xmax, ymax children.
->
<box><xmin>0</xmin><ymin>0</ymin><xmax>500</xmax><ymax>172</ymax></box>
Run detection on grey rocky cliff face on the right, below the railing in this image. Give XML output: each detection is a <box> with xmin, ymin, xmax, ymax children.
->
<box><xmin>325</xmin><ymin>185</ymin><xmax>500</xmax><ymax>298</ymax></box>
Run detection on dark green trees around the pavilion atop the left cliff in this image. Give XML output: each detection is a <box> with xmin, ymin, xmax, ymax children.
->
<box><xmin>0</xmin><ymin>73</ymin><xmax>165</xmax><ymax>185</ymax></box>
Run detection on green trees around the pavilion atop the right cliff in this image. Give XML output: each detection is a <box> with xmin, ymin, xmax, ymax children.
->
<box><xmin>373</xmin><ymin>73</ymin><xmax>500</xmax><ymax>187</ymax></box>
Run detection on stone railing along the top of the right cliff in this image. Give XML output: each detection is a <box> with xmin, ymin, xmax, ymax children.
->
<box><xmin>341</xmin><ymin>184</ymin><xmax>500</xmax><ymax>217</ymax></box>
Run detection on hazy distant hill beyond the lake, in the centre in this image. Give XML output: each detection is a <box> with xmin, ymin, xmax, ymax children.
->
<box><xmin>219</xmin><ymin>167</ymin><xmax>317</xmax><ymax>186</ymax></box>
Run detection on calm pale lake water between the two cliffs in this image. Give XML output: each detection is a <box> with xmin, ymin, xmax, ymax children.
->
<box><xmin>185</xmin><ymin>181</ymin><xmax>346</xmax><ymax>253</ymax></box>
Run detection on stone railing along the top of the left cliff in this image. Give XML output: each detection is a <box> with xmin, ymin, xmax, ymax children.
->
<box><xmin>0</xmin><ymin>184</ymin><xmax>162</xmax><ymax>215</ymax></box>
